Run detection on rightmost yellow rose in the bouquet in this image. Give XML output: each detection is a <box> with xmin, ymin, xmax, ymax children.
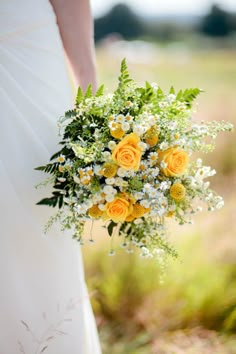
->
<box><xmin>159</xmin><ymin>147</ymin><xmax>189</xmax><ymax>177</ymax></box>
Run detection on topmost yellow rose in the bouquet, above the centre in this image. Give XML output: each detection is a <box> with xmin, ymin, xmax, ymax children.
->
<box><xmin>112</xmin><ymin>133</ymin><xmax>142</xmax><ymax>171</ymax></box>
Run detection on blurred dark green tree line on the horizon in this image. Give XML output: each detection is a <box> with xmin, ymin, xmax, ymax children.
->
<box><xmin>95</xmin><ymin>3</ymin><xmax>236</xmax><ymax>41</ymax></box>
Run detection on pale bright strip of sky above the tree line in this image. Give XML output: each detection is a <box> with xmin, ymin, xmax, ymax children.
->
<box><xmin>90</xmin><ymin>0</ymin><xmax>236</xmax><ymax>17</ymax></box>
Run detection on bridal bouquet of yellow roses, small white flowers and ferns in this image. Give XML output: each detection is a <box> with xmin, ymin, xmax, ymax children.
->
<box><xmin>36</xmin><ymin>60</ymin><xmax>232</xmax><ymax>257</ymax></box>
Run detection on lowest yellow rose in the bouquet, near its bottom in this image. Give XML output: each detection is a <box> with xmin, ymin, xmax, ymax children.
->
<box><xmin>105</xmin><ymin>197</ymin><xmax>133</xmax><ymax>223</ymax></box>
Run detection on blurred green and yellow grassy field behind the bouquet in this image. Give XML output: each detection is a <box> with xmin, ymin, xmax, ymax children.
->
<box><xmin>83</xmin><ymin>1</ymin><xmax>236</xmax><ymax>354</ymax></box>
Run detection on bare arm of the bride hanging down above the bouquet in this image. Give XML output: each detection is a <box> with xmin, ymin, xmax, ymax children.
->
<box><xmin>50</xmin><ymin>0</ymin><xmax>96</xmax><ymax>90</ymax></box>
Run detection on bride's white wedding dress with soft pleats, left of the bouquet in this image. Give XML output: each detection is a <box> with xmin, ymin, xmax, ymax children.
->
<box><xmin>0</xmin><ymin>0</ymin><xmax>101</xmax><ymax>354</ymax></box>
